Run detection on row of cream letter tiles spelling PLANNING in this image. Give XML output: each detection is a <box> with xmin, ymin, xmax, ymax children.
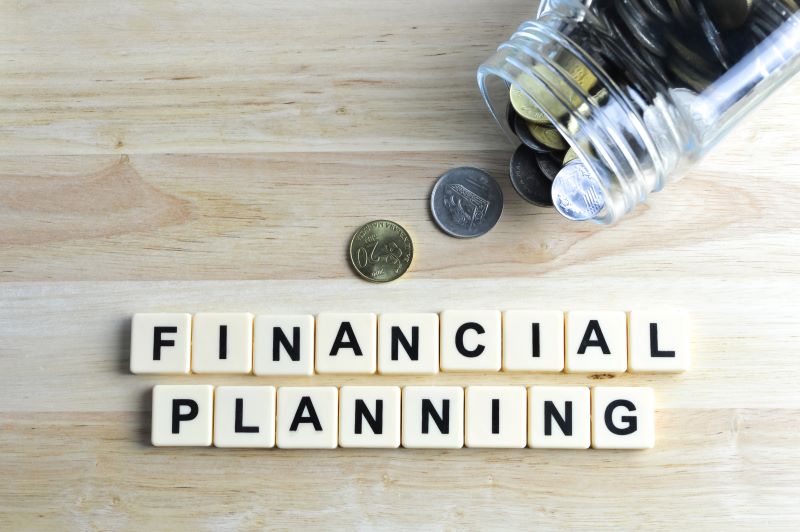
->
<box><xmin>152</xmin><ymin>385</ymin><xmax>655</xmax><ymax>449</ymax></box>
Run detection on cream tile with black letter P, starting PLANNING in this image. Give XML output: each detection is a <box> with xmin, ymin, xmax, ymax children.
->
<box><xmin>151</xmin><ymin>384</ymin><xmax>214</xmax><ymax>447</ymax></box>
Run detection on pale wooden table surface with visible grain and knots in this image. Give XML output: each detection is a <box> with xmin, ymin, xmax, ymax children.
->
<box><xmin>0</xmin><ymin>0</ymin><xmax>800</xmax><ymax>530</ymax></box>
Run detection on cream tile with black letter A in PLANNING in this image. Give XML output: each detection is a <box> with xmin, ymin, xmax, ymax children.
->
<box><xmin>276</xmin><ymin>386</ymin><xmax>339</xmax><ymax>449</ymax></box>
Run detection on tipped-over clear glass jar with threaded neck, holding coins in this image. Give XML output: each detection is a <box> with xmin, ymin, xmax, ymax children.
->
<box><xmin>478</xmin><ymin>0</ymin><xmax>800</xmax><ymax>223</ymax></box>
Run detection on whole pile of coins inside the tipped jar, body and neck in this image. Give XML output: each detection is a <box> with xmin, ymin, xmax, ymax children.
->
<box><xmin>500</xmin><ymin>0</ymin><xmax>800</xmax><ymax>208</ymax></box>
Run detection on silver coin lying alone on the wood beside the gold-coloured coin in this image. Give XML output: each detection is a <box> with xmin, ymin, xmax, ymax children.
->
<box><xmin>431</xmin><ymin>166</ymin><xmax>503</xmax><ymax>238</ymax></box>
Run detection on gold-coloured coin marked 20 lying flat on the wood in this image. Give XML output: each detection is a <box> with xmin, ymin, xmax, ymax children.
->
<box><xmin>350</xmin><ymin>220</ymin><xmax>414</xmax><ymax>283</ymax></box>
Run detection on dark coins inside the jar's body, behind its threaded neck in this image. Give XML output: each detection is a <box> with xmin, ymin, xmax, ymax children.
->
<box><xmin>578</xmin><ymin>0</ymin><xmax>798</xmax><ymax>95</ymax></box>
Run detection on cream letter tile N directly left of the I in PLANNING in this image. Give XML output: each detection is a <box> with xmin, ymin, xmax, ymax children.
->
<box><xmin>402</xmin><ymin>386</ymin><xmax>464</xmax><ymax>449</ymax></box>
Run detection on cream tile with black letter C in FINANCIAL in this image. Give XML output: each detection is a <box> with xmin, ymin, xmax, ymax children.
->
<box><xmin>439</xmin><ymin>310</ymin><xmax>502</xmax><ymax>371</ymax></box>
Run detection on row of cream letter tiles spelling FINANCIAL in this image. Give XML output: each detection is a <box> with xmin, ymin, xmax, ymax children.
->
<box><xmin>131</xmin><ymin>310</ymin><xmax>690</xmax><ymax>376</ymax></box>
